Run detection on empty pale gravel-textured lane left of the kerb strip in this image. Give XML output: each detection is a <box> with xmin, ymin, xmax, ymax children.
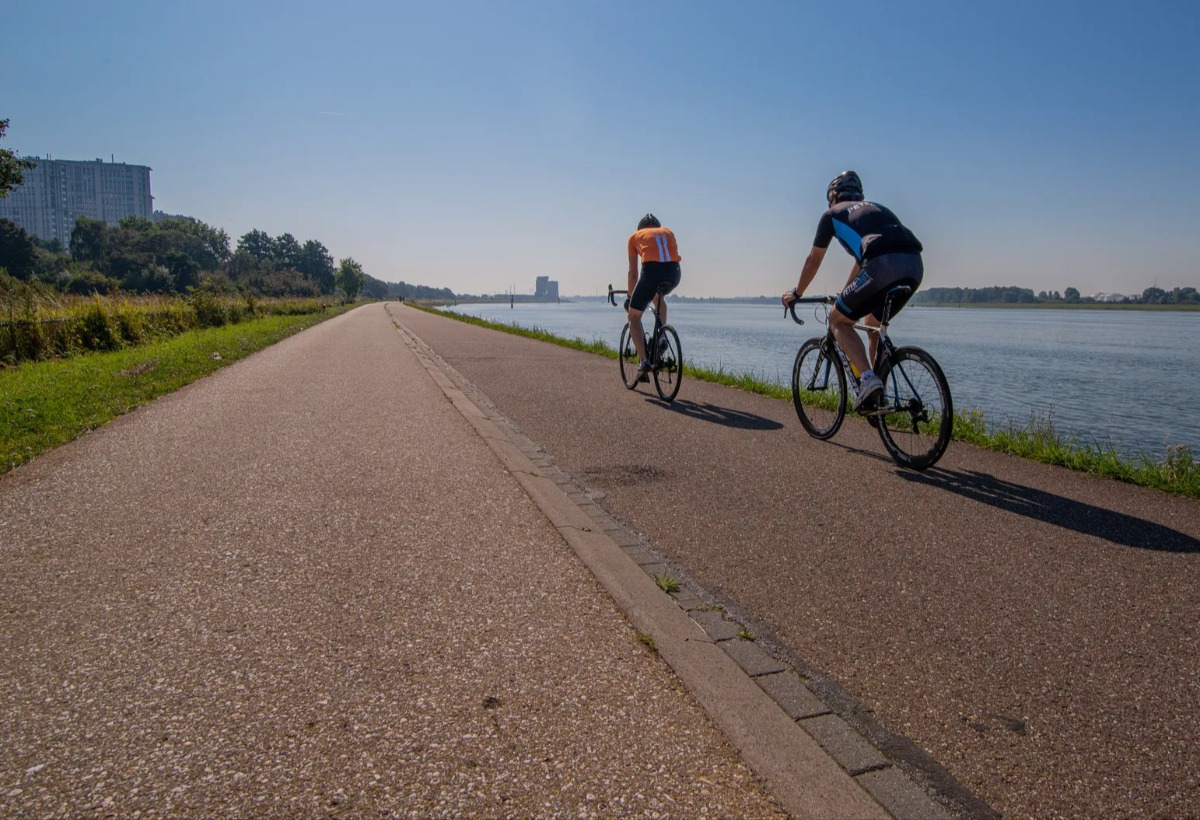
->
<box><xmin>0</xmin><ymin>305</ymin><xmax>779</xmax><ymax>818</ymax></box>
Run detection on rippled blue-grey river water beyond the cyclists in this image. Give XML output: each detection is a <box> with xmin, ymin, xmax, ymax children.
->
<box><xmin>451</xmin><ymin>299</ymin><xmax>1200</xmax><ymax>460</ymax></box>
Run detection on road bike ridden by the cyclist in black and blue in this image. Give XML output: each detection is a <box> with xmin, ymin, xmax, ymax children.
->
<box><xmin>787</xmin><ymin>286</ymin><xmax>954</xmax><ymax>469</ymax></box>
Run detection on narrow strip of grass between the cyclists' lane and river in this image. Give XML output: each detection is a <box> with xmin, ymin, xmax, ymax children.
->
<box><xmin>413</xmin><ymin>305</ymin><xmax>1200</xmax><ymax>498</ymax></box>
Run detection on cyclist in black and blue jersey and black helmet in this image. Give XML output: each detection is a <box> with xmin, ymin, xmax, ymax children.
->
<box><xmin>784</xmin><ymin>170</ymin><xmax>924</xmax><ymax>411</ymax></box>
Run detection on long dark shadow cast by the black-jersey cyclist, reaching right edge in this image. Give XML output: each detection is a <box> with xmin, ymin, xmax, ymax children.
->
<box><xmin>896</xmin><ymin>467</ymin><xmax>1200</xmax><ymax>552</ymax></box>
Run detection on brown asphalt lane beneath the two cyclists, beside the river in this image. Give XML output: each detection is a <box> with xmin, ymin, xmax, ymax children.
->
<box><xmin>389</xmin><ymin>305</ymin><xmax>1200</xmax><ymax>818</ymax></box>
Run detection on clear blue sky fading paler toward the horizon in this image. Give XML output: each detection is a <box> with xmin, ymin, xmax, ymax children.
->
<box><xmin>0</xmin><ymin>0</ymin><xmax>1200</xmax><ymax>297</ymax></box>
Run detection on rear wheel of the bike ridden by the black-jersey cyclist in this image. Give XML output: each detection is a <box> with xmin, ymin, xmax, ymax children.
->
<box><xmin>874</xmin><ymin>347</ymin><xmax>954</xmax><ymax>469</ymax></box>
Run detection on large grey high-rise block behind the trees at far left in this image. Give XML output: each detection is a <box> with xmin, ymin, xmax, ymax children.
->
<box><xmin>0</xmin><ymin>156</ymin><xmax>154</xmax><ymax>247</ymax></box>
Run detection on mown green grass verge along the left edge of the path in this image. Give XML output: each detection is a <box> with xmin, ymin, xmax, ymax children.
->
<box><xmin>0</xmin><ymin>310</ymin><xmax>341</xmax><ymax>473</ymax></box>
